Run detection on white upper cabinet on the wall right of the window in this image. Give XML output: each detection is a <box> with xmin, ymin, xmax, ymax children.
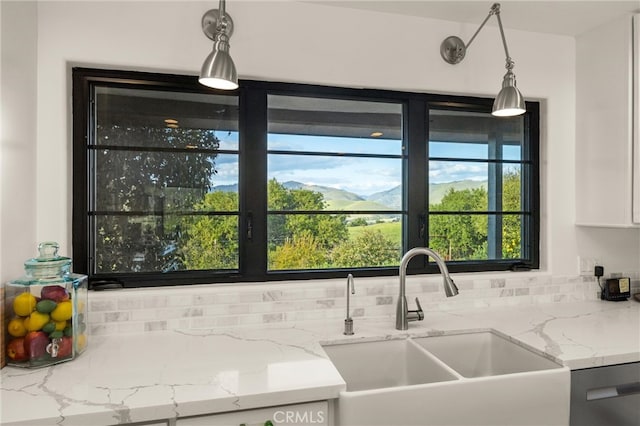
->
<box><xmin>576</xmin><ymin>15</ymin><xmax>640</xmax><ymax>227</ymax></box>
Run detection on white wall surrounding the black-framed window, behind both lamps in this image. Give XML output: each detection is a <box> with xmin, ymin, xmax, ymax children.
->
<box><xmin>2</xmin><ymin>0</ymin><xmax>640</xmax><ymax>274</ymax></box>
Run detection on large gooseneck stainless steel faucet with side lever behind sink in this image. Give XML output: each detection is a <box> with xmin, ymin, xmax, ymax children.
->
<box><xmin>396</xmin><ymin>247</ymin><xmax>458</xmax><ymax>330</ymax></box>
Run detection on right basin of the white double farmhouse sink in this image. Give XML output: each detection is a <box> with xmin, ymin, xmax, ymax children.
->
<box><xmin>414</xmin><ymin>332</ymin><xmax>558</xmax><ymax>377</ymax></box>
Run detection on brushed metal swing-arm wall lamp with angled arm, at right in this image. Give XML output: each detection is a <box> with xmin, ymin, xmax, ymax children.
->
<box><xmin>440</xmin><ymin>3</ymin><xmax>526</xmax><ymax>117</ymax></box>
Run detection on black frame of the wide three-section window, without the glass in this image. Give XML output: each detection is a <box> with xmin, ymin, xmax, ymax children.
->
<box><xmin>72</xmin><ymin>67</ymin><xmax>540</xmax><ymax>288</ymax></box>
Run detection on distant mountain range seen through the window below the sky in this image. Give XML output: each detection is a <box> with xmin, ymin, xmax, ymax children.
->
<box><xmin>213</xmin><ymin>179</ymin><xmax>487</xmax><ymax>210</ymax></box>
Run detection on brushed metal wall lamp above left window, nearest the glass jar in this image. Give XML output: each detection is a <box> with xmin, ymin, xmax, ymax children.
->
<box><xmin>198</xmin><ymin>0</ymin><xmax>238</xmax><ymax>90</ymax></box>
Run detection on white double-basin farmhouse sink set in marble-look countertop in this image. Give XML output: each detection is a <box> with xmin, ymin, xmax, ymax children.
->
<box><xmin>323</xmin><ymin>332</ymin><xmax>570</xmax><ymax>426</ymax></box>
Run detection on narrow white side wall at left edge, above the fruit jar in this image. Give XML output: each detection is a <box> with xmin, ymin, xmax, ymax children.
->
<box><xmin>0</xmin><ymin>1</ymin><xmax>38</xmax><ymax>283</ymax></box>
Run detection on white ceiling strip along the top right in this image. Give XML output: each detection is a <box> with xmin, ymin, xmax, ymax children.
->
<box><xmin>309</xmin><ymin>0</ymin><xmax>640</xmax><ymax>36</ymax></box>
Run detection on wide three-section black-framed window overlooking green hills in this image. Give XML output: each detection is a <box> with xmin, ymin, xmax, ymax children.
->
<box><xmin>73</xmin><ymin>68</ymin><xmax>539</xmax><ymax>286</ymax></box>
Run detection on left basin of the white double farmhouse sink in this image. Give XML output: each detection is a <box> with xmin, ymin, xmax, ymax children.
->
<box><xmin>324</xmin><ymin>339</ymin><xmax>457</xmax><ymax>391</ymax></box>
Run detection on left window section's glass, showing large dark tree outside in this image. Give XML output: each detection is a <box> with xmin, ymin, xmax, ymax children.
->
<box><xmin>89</xmin><ymin>86</ymin><xmax>239</xmax><ymax>273</ymax></box>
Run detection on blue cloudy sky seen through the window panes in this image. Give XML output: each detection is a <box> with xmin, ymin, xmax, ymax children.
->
<box><xmin>214</xmin><ymin>132</ymin><xmax>520</xmax><ymax>196</ymax></box>
